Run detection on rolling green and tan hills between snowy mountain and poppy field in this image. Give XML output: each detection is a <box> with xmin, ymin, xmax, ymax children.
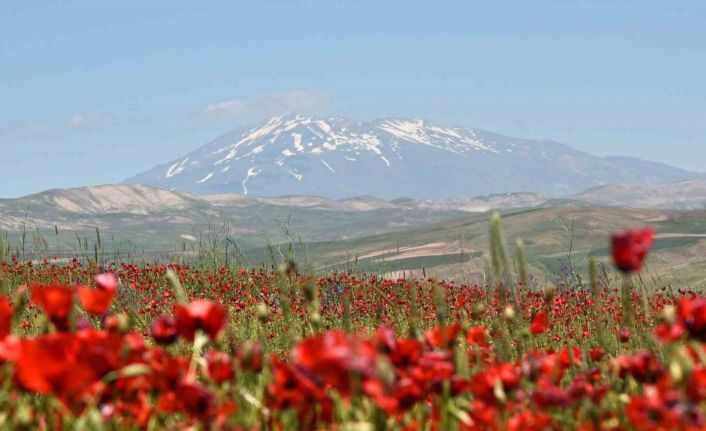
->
<box><xmin>0</xmin><ymin>180</ymin><xmax>706</xmax><ymax>286</ymax></box>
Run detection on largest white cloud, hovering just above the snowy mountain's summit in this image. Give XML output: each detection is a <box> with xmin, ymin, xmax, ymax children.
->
<box><xmin>201</xmin><ymin>90</ymin><xmax>330</xmax><ymax>123</ymax></box>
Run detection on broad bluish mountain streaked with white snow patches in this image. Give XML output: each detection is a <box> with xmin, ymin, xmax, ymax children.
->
<box><xmin>124</xmin><ymin>115</ymin><xmax>695</xmax><ymax>199</ymax></box>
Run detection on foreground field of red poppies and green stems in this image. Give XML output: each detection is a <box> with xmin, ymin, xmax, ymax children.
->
<box><xmin>0</xmin><ymin>217</ymin><xmax>706</xmax><ymax>431</ymax></box>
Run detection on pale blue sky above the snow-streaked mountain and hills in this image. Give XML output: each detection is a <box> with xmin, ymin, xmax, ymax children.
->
<box><xmin>0</xmin><ymin>0</ymin><xmax>706</xmax><ymax>197</ymax></box>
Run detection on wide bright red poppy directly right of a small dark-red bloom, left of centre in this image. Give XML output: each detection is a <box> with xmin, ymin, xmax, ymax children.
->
<box><xmin>174</xmin><ymin>300</ymin><xmax>228</xmax><ymax>341</ymax></box>
